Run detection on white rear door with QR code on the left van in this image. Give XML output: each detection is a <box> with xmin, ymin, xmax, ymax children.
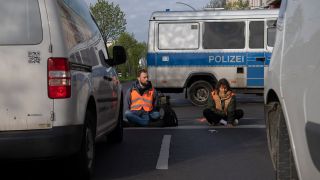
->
<box><xmin>0</xmin><ymin>0</ymin><xmax>53</xmax><ymax>131</ymax></box>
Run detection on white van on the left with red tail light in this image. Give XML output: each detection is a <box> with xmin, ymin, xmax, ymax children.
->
<box><xmin>0</xmin><ymin>0</ymin><xmax>126</xmax><ymax>175</ymax></box>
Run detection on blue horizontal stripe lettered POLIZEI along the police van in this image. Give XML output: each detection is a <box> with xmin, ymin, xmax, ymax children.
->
<box><xmin>147</xmin><ymin>52</ymin><xmax>271</xmax><ymax>66</ymax></box>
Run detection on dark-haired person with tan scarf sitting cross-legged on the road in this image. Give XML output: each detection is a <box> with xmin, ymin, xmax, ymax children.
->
<box><xmin>203</xmin><ymin>78</ymin><xmax>243</xmax><ymax>126</ymax></box>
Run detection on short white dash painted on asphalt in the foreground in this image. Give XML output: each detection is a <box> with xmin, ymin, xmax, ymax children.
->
<box><xmin>156</xmin><ymin>135</ymin><xmax>171</xmax><ymax>169</ymax></box>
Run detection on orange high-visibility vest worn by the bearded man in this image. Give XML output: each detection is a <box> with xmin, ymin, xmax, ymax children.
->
<box><xmin>130</xmin><ymin>88</ymin><xmax>154</xmax><ymax>112</ymax></box>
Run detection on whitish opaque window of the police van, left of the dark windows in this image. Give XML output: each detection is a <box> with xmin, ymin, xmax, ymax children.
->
<box><xmin>158</xmin><ymin>23</ymin><xmax>199</xmax><ymax>50</ymax></box>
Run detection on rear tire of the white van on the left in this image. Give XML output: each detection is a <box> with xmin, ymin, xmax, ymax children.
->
<box><xmin>76</xmin><ymin>110</ymin><xmax>95</xmax><ymax>179</ymax></box>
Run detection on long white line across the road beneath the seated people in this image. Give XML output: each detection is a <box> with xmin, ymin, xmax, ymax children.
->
<box><xmin>125</xmin><ymin>124</ymin><xmax>266</xmax><ymax>130</ymax></box>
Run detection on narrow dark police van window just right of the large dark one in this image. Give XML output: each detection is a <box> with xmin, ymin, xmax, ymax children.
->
<box><xmin>249</xmin><ymin>21</ymin><xmax>264</xmax><ymax>49</ymax></box>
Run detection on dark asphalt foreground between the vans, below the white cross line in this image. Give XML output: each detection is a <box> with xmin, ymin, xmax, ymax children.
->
<box><xmin>94</xmin><ymin>128</ymin><xmax>275</xmax><ymax>180</ymax></box>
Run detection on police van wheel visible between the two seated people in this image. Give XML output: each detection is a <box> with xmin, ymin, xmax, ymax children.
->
<box><xmin>188</xmin><ymin>81</ymin><xmax>213</xmax><ymax>106</ymax></box>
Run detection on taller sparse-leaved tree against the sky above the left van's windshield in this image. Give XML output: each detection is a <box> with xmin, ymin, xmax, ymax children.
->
<box><xmin>90</xmin><ymin>0</ymin><xmax>127</xmax><ymax>42</ymax></box>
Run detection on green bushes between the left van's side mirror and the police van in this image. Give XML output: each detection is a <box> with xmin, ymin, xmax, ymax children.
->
<box><xmin>109</xmin><ymin>32</ymin><xmax>147</xmax><ymax>79</ymax></box>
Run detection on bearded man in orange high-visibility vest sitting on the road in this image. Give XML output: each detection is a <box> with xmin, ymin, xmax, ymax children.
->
<box><xmin>125</xmin><ymin>69</ymin><xmax>160</xmax><ymax>126</ymax></box>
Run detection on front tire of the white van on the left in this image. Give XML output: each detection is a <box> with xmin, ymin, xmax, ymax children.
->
<box><xmin>107</xmin><ymin>98</ymin><xmax>123</xmax><ymax>143</ymax></box>
